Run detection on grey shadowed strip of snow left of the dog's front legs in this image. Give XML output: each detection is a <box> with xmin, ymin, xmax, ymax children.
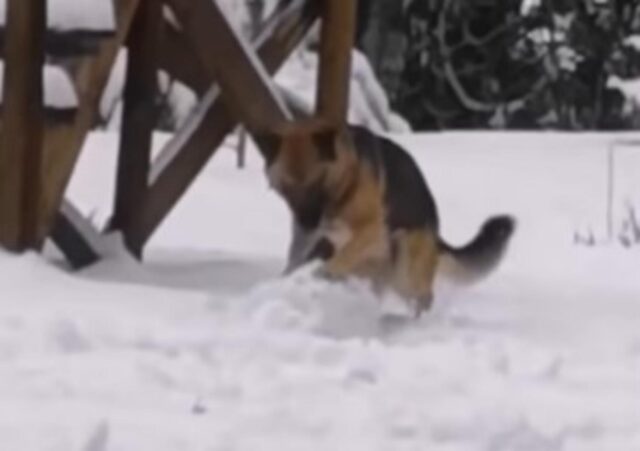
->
<box><xmin>81</xmin><ymin>250</ymin><xmax>283</xmax><ymax>295</ymax></box>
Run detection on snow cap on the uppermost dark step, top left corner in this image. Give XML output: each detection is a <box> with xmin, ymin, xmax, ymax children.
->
<box><xmin>0</xmin><ymin>0</ymin><xmax>115</xmax><ymax>31</ymax></box>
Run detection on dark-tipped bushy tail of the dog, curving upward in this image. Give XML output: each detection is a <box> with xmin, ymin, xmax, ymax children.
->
<box><xmin>438</xmin><ymin>215</ymin><xmax>516</xmax><ymax>284</ymax></box>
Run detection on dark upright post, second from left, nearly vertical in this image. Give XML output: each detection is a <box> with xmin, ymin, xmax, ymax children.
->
<box><xmin>110</xmin><ymin>0</ymin><xmax>162</xmax><ymax>257</ymax></box>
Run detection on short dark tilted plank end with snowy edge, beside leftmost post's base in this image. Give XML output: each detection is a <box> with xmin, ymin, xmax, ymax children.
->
<box><xmin>51</xmin><ymin>201</ymin><xmax>100</xmax><ymax>269</ymax></box>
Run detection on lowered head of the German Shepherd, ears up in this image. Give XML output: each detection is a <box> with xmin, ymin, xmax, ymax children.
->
<box><xmin>255</xmin><ymin>122</ymin><xmax>342</xmax><ymax>229</ymax></box>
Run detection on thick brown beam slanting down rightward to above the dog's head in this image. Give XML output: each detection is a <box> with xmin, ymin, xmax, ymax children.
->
<box><xmin>170</xmin><ymin>0</ymin><xmax>289</xmax><ymax>130</ymax></box>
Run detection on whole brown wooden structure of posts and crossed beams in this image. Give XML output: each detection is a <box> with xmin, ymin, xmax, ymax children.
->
<box><xmin>0</xmin><ymin>0</ymin><xmax>356</xmax><ymax>267</ymax></box>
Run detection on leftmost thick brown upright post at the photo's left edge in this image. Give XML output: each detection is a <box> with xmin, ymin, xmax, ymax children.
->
<box><xmin>0</xmin><ymin>0</ymin><xmax>46</xmax><ymax>252</ymax></box>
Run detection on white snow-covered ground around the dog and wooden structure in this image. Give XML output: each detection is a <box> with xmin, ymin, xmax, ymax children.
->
<box><xmin>0</xmin><ymin>133</ymin><xmax>640</xmax><ymax>451</ymax></box>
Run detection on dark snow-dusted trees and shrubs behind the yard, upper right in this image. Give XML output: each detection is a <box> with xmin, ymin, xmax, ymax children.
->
<box><xmin>356</xmin><ymin>0</ymin><xmax>640</xmax><ymax>130</ymax></box>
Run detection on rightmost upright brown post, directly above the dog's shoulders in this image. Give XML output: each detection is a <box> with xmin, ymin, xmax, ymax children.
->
<box><xmin>316</xmin><ymin>0</ymin><xmax>357</xmax><ymax>124</ymax></box>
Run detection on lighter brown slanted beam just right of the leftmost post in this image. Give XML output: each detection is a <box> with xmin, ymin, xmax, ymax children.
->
<box><xmin>39</xmin><ymin>0</ymin><xmax>140</xmax><ymax>247</ymax></box>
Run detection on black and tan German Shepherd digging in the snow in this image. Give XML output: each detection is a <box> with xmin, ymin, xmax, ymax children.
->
<box><xmin>256</xmin><ymin>119</ymin><xmax>515</xmax><ymax>315</ymax></box>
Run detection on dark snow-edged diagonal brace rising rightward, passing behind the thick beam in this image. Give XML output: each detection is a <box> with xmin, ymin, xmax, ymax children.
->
<box><xmin>129</xmin><ymin>0</ymin><xmax>318</xmax><ymax>247</ymax></box>
